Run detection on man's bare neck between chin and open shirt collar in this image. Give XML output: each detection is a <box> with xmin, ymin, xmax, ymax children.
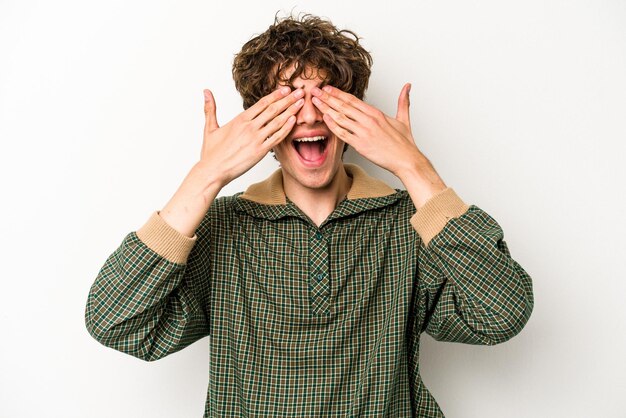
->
<box><xmin>283</xmin><ymin>165</ymin><xmax>352</xmax><ymax>226</ymax></box>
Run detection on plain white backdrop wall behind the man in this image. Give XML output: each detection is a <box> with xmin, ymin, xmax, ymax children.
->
<box><xmin>0</xmin><ymin>0</ymin><xmax>626</xmax><ymax>418</ymax></box>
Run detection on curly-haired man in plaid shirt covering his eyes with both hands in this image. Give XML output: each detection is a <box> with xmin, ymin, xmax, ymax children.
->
<box><xmin>86</xmin><ymin>15</ymin><xmax>533</xmax><ymax>417</ymax></box>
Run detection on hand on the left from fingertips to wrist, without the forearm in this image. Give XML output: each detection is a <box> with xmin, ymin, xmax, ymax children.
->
<box><xmin>199</xmin><ymin>86</ymin><xmax>304</xmax><ymax>187</ymax></box>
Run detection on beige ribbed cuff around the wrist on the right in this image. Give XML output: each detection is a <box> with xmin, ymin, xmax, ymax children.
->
<box><xmin>411</xmin><ymin>187</ymin><xmax>469</xmax><ymax>245</ymax></box>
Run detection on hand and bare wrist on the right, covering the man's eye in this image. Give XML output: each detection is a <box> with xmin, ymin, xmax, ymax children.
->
<box><xmin>311</xmin><ymin>83</ymin><xmax>446</xmax><ymax>207</ymax></box>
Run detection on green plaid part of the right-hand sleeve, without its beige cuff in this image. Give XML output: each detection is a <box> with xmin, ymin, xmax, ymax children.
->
<box><xmin>418</xmin><ymin>206</ymin><xmax>534</xmax><ymax>345</ymax></box>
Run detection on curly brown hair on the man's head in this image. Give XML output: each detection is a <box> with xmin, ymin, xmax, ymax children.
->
<box><xmin>233</xmin><ymin>14</ymin><xmax>372</xmax><ymax>109</ymax></box>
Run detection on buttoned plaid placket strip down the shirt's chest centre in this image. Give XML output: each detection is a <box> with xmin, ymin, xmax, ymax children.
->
<box><xmin>309</xmin><ymin>228</ymin><xmax>330</xmax><ymax>316</ymax></box>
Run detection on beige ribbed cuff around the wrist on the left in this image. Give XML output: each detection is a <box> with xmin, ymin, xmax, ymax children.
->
<box><xmin>136</xmin><ymin>211</ymin><xmax>198</xmax><ymax>264</ymax></box>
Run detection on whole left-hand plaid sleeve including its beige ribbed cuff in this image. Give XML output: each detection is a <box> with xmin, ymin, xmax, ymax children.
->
<box><xmin>85</xmin><ymin>212</ymin><xmax>209</xmax><ymax>361</ymax></box>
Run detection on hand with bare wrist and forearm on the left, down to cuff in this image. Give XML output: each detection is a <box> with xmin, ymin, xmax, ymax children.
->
<box><xmin>160</xmin><ymin>87</ymin><xmax>304</xmax><ymax>237</ymax></box>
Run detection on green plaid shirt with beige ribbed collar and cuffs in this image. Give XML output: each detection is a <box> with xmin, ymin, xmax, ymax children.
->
<box><xmin>86</xmin><ymin>165</ymin><xmax>533</xmax><ymax>417</ymax></box>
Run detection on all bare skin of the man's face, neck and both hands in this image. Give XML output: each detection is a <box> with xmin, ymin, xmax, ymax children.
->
<box><xmin>160</xmin><ymin>65</ymin><xmax>446</xmax><ymax>237</ymax></box>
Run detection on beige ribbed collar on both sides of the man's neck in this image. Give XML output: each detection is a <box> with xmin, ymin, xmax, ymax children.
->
<box><xmin>239</xmin><ymin>164</ymin><xmax>396</xmax><ymax>205</ymax></box>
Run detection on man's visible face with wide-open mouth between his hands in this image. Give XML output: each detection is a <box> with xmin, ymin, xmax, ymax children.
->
<box><xmin>274</xmin><ymin>66</ymin><xmax>344</xmax><ymax>191</ymax></box>
